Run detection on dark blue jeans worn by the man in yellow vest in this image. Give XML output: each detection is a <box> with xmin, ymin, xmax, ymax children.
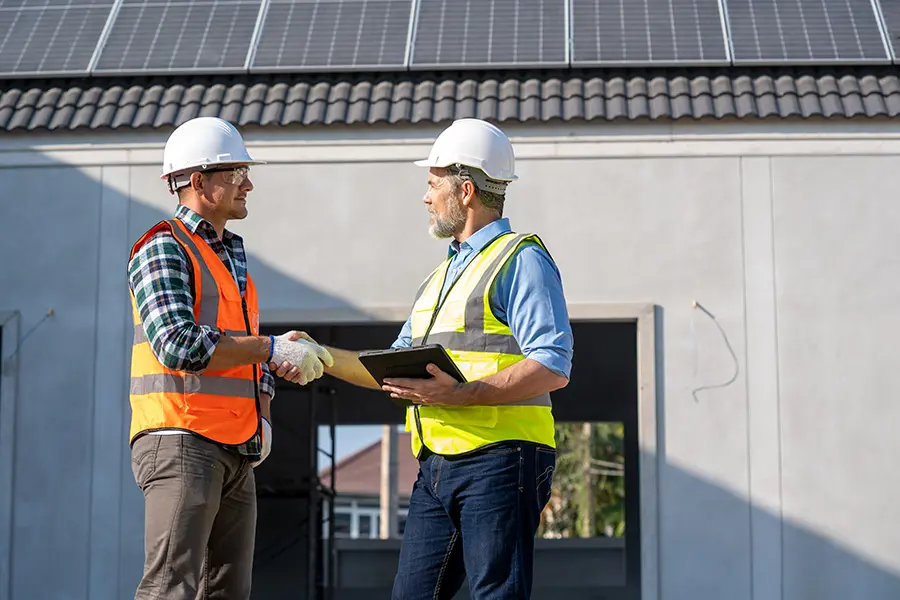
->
<box><xmin>392</xmin><ymin>442</ymin><xmax>556</xmax><ymax>600</ymax></box>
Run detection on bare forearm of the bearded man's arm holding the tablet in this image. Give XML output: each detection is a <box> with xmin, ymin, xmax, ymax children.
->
<box><xmin>463</xmin><ymin>358</ymin><xmax>569</xmax><ymax>406</ymax></box>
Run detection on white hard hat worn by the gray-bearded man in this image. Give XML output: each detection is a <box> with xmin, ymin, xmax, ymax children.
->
<box><xmin>415</xmin><ymin>119</ymin><xmax>518</xmax><ymax>182</ymax></box>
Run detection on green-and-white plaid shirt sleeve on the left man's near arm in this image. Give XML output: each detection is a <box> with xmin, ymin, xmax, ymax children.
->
<box><xmin>128</xmin><ymin>232</ymin><xmax>220</xmax><ymax>373</ymax></box>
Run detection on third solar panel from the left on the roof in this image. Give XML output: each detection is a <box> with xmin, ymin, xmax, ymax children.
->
<box><xmin>251</xmin><ymin>0</ymin><xmax>412</xmax><ymax>71</ymax></box>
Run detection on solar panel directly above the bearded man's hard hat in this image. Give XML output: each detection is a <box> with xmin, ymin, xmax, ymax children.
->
<box><xmin>411</xmin><ymin>0</ymin><xmax>568</xmax><ymax>68</ymax></box>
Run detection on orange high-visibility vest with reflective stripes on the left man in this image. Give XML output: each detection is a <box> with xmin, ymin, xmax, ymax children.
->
<box><xmin>129</xmin><ymin>219</ymin><xmax>262</xmax><ymax>445</ymax></box>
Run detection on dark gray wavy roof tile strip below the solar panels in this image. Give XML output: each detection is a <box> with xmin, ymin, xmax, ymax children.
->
<box><xmin>0</xmin><ymin>67</ymin><xmax>900</xmax><ymax>131</ymax></box>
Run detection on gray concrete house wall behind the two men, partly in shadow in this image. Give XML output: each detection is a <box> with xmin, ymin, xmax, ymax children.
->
<box><xmin>0</xmin><ymin>122</ymin><xmax>900</xmax><ymax>600</ymax></box>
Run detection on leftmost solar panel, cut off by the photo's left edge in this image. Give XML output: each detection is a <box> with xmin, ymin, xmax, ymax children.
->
<box><xmin>0</xmin><ymin>0</ymin><xmax>113</xmax><ymax>76</ymax></box>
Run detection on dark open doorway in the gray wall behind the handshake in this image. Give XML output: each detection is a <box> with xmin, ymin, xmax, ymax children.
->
<box><xmin>253</xmin><ymin>321</ymin><xmax>641</xmax><ymax>600</ymax></box>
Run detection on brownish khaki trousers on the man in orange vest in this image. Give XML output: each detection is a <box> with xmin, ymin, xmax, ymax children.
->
<box><xmin>131</xmin><ymin>434</ymin><xmax>256</xmax><ymax>600</ymax></box>
